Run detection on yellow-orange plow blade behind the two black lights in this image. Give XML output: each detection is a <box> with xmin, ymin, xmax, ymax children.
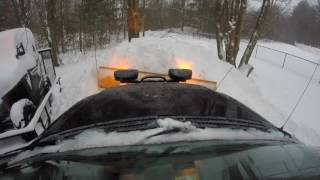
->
<box><xmin>98</xmin><ymin>66</ymin><xmax>217</xmax><ymax>90</ymax></box>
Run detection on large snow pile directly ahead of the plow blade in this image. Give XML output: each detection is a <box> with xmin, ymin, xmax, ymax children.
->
<box><xmin>99</xmin><ymin>31</ymin><xmax>230</xmax><ymax>80</ymax></box>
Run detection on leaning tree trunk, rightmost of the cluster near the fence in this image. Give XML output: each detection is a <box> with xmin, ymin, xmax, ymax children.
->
<box><xmin>239</xmin><ymin>0</ymin><xmax>270</xmax><ymax>67</ymax></box>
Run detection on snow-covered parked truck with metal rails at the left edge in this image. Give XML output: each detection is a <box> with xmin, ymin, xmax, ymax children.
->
<box><xmin>0</xmin><ymin>28</ymin><xmax>56</xmax><ymax>146</ymax></box>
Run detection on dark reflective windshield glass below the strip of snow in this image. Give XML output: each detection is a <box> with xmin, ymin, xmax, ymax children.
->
<box><xmin>0</xmin><ymin>141</ymin><xmax>320</xmax><ymax>180</ymax></box>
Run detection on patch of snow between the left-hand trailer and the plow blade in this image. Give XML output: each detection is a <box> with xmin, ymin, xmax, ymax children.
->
<box><xmin>52</xmin><ymin>51</ymin><xmax>108</xmax><ymax>119</ymax></box>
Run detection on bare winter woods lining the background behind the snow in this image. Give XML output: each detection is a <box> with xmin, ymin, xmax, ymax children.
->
<box><xmin>0</xmin><ymin>0</ymin><xmax>320</xmax><ymax>66</ymax></box>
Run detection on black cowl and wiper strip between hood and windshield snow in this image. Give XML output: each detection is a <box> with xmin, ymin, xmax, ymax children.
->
<box><xmin>35</xmin><ymin>116</ymin><xmax>287</xmax><ymax>146</ymax></box>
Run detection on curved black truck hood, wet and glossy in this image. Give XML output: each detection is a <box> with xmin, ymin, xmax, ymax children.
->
<box><xmin>43</xmin><ymin>82</ymin><xmax>278</xmax><ymax>136</ymax></box>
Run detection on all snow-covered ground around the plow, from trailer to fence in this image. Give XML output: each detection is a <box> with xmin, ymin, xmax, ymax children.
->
<box><xmin>53</xmin><ymin>31</ymin><xmax>320</xmax><ymax>146</ymax></box>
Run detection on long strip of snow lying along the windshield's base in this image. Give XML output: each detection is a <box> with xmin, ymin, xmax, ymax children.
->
<box><xmin>11</xmin><ymin>118</ymin><xmax>285</xmax><ymax>163</ymax></box>
